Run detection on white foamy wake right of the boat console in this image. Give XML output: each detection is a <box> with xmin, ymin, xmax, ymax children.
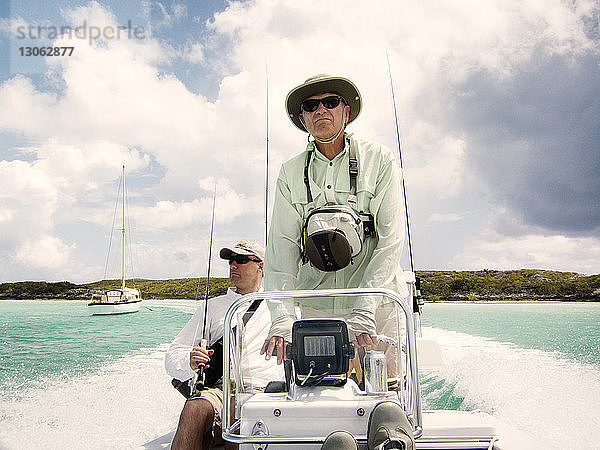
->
<box><xmin>423</xmin><ymin>327</ymin><xmax>600</xmax><ymax>450</ymax></box>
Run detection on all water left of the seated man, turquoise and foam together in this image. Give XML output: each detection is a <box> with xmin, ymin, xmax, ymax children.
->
<box><xmin>0</xmin><ymin>300</ymin><xmax>198</xmax><ymax>450</ymax></box>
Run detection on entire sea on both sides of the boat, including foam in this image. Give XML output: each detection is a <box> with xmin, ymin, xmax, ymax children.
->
<box><xmin>0</xmin><ymin>300</ymin><xmax>600</xmax><ymax>450</ymax></box>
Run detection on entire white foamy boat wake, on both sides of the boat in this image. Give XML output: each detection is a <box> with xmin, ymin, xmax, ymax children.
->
<box><xmin>0</xmin><ymin>320</ymin><xmax>600</xmax><ymax>450</ymax></box>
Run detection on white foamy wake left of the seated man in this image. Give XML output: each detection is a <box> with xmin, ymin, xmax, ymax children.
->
<box><xmin>0</xmin><ymin>344</ymin><xmax>184</xmax><ymax>450</ymax></box>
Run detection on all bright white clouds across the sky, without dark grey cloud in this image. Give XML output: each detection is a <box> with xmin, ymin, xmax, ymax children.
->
<box><xmin>0</xmin><ymin>0</ymin><xmax>598</xmax><ymax>278</ymax></box>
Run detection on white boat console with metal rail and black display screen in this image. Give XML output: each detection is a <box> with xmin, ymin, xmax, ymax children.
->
<box><xmin>222</xmin><ymin>289</ymin><xmax>505</xmax><ymax>450</ymax></box>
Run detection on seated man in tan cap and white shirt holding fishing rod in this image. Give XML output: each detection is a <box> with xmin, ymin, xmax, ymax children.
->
<box><xmin>165</xmin><ymin>241</ymin><xmax>282</xmax><ymax>449</ymax></box>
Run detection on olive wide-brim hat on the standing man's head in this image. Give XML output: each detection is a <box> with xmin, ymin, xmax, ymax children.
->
<box><xmin>285</xmin><ymin>74</ymin><xmax>362</xmax><ymax>131</ymax></box>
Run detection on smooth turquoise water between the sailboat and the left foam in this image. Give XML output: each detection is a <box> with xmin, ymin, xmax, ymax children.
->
<box><xmin>0</xmin><ymin>301</ymin><xmax>190</xmax><ymax>395</ymax></box>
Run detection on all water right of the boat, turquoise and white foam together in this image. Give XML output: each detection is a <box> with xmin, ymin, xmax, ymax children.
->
<box><xmin>420</xmin><ymin>303</ymin><xmax>600</xmax><ymax>449</ymax></box>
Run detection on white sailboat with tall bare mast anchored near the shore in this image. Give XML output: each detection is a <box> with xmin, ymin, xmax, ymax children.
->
<box><xmin>88</xmin><ymin>166</ymin><xmax>142</xmax><ymax>315</ymax></box>
